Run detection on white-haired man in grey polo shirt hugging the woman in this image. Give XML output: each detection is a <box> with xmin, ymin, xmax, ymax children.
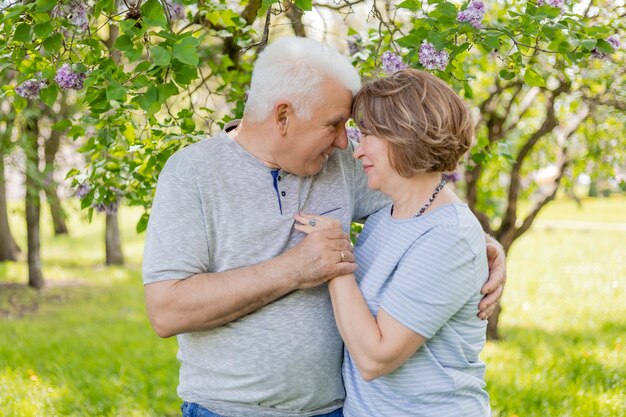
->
<box><xmin>143</xmin><ymin>38</ymin><xmax>504</xmax><ymax>417</ymax></box>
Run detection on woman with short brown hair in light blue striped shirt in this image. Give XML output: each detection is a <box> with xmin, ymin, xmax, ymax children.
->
<box><xmin>295</xmin><ymin>69</ymin><xmax>490</xmax><ymax>417</ymax></box>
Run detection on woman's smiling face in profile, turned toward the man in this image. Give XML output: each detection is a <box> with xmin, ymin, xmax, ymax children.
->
<box><xmin>353</xmin><ymin>132</ymin><xmax>399</xmax><ymax>195</ymax></box>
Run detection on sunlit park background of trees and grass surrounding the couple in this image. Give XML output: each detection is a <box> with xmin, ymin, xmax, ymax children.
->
<box><xmin>0</xmin><ymin>0</ymin><xmax>626</xmax><ymax>417</ymax></box>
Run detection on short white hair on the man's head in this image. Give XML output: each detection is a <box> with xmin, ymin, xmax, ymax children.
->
<box><xmin>244</xmin><ymin>37</ymin><xmax>361</xmax><ymax>122</ymax></box>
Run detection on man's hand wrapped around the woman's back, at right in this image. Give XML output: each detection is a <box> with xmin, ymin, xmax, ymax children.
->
<box><xmin>478</xmin><ymin>235</ymin><xmax>506</xmax><ymax>320</ymax></box>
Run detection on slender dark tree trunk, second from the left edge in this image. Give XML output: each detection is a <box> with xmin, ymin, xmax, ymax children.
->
<box><xmin>22</xmin><ymin>116</ymin><xmax>44</xmax><ymax>289</ymax></box>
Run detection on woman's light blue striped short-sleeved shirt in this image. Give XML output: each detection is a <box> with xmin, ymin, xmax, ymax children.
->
<box><xmin>343</xmin><ymin>203</ymin><xmax>490</xmax><ymax>417</ymax></box>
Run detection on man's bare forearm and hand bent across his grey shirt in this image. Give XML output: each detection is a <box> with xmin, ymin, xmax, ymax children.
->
<box><xmin>144</xmin><ymin>229</ymin><xmax>356</xmax><ymax>337</ymax></box>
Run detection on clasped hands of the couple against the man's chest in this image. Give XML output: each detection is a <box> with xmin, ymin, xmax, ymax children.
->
<box><xmin>285</xmin><ymin>213</ymin><xmax>357</xmax><ymax>288</ymax></box>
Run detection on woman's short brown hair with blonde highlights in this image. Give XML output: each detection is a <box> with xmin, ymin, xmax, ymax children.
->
<box><xmin>352</xmin><ymin>69</ymin><xmax>474</xmax><ymax>178</ymax></box>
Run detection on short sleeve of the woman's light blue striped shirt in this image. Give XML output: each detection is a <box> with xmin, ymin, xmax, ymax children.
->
<box><xmin>381</xmin><ymin>225</ymin><xmax>477</xmax><ymax>339</ymax></box>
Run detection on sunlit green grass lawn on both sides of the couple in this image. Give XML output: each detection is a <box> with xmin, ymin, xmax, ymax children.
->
<box><xmin>0</xmin><ymin>197</ymin><xmax>626</xmax><ymax>417</ymax></box>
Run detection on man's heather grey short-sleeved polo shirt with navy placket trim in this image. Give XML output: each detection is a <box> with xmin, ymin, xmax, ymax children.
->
<box><xmin>143</xmin><ymin>124</ymin><xmax>388</xmax><ymax>417</ymax></box>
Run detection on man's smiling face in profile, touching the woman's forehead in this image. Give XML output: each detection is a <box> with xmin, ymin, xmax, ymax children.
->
<box><xmin>278</xmin><ymin>78</ymin><xmax>352</xmax><ymax>176</ymax></box>
